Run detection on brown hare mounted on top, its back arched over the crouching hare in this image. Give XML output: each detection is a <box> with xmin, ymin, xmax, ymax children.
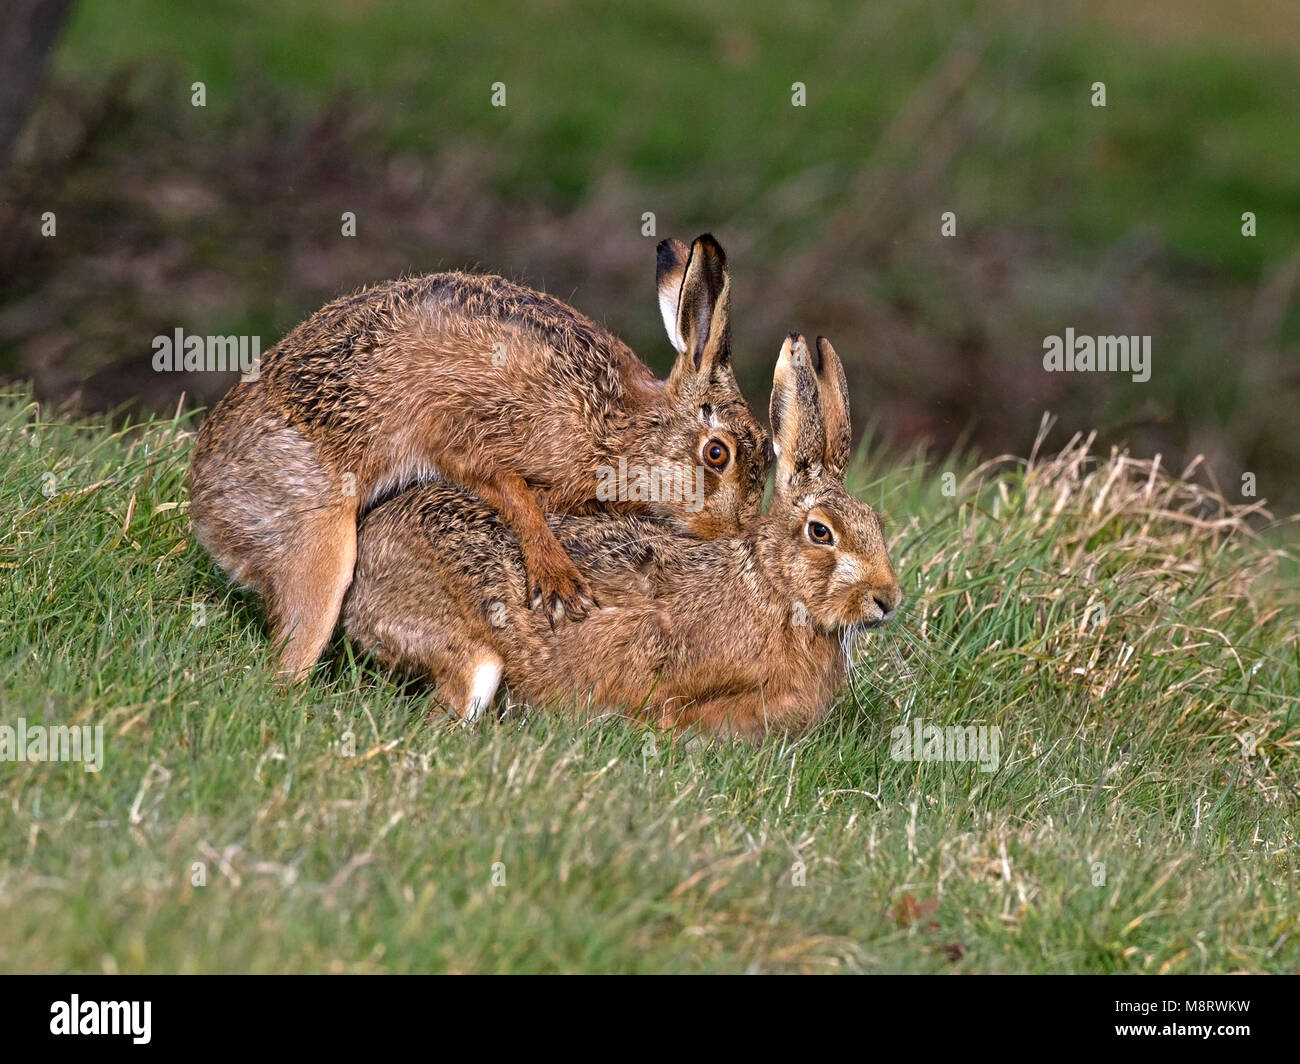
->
<box><xmin>190</xmin><ymin>235</ymin><xmax>768</xmax><ymax>676</ymax></box>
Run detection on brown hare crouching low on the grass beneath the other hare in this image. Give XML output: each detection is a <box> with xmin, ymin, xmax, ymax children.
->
<box><xmin>343</xmin><ymin>334</ymin><xmax>901</xmax><ymax>738</ymax></box>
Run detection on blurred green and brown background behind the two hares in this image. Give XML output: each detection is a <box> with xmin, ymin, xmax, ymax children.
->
<box><xmin>0</xmin><ymin>0</ymin><xmax>1300</xmax><ymax>509</ymax></box>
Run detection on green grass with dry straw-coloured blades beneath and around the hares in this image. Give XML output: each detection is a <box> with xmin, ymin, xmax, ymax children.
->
<box><xmin>0</xmin><ymin>394</ymin><xmax>1300</xmax><ymax>972</ymax></box>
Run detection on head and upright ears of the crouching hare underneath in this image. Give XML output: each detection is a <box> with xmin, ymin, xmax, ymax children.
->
<box><xmin>759</xmin><ymin>333</ymin><xmax>902</xmax><ymax>632</ymax></box>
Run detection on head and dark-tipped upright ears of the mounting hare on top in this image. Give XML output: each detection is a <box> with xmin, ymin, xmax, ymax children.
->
<box><xmin>653</xmin><ymin>233</ymin><xmax>771</xmax><ymax>539</ymax></box>
